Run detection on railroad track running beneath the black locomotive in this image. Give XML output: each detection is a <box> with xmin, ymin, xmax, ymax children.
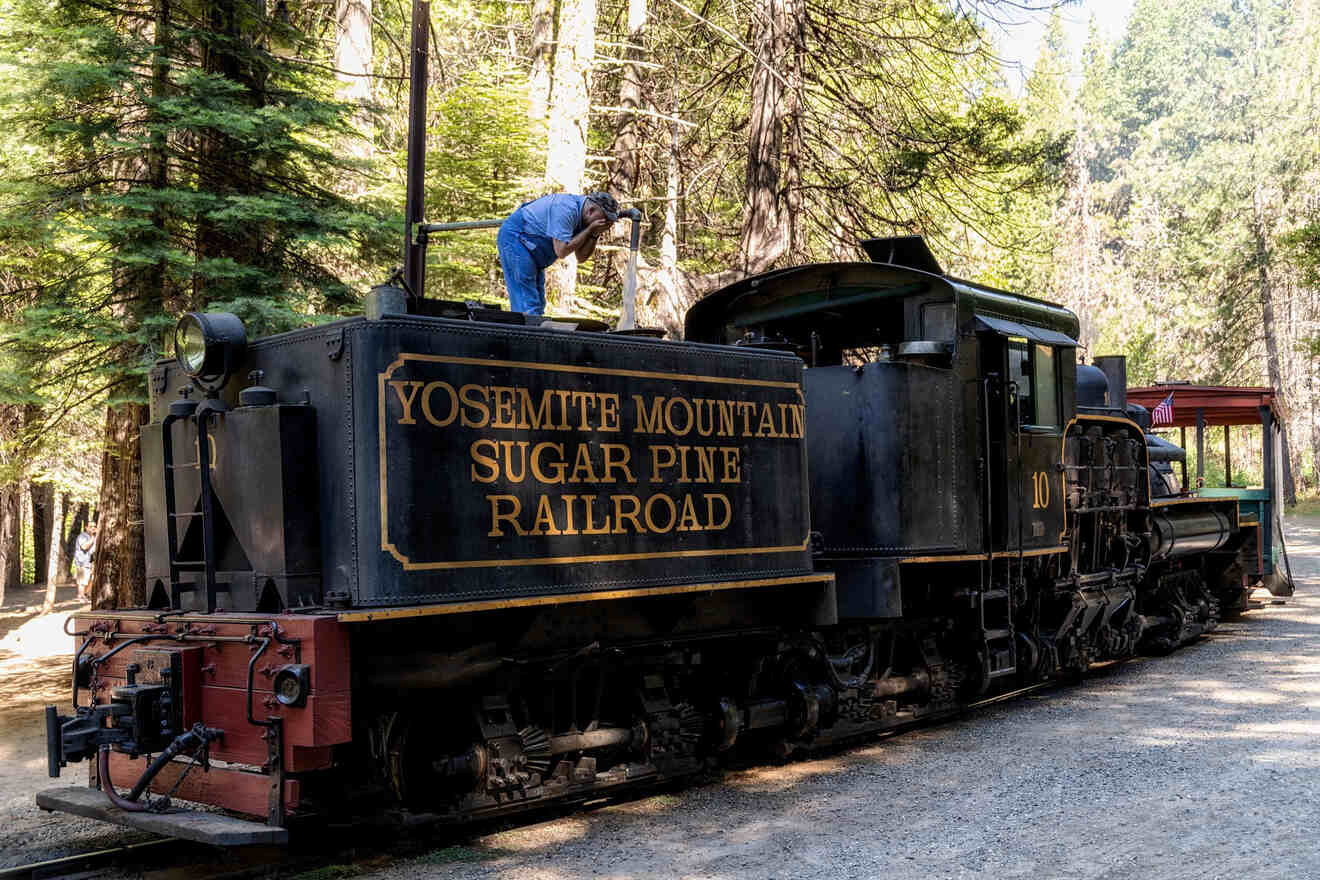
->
<box><xmin>0</xmin><ymin>643</ymin><xmax>1188</xmax><ymax>880</ymax></box>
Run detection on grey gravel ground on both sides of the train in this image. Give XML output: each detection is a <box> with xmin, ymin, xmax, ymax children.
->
<box><xmin>0</xmin><ymin>519</ymin><xmax>1320</xmax><ymax>880</ymax></box>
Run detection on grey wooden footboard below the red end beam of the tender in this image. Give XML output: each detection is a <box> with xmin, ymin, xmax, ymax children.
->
<box><xmin>37</xmin><ymin>786</ymin><xmax>289</xmax><ymax>847</ymax></box>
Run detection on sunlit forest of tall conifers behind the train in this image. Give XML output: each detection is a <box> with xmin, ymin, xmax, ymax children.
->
<box><xmin>0</xmin><ymin>0</ymin><xmax>1320</xmax><ymax>604</ymax></box>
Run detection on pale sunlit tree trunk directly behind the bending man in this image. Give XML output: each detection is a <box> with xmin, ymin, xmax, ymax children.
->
<box><xmin>545</xmin><ymin>0</ymin><xmax>597</xmax><ymax>311</ymax></box>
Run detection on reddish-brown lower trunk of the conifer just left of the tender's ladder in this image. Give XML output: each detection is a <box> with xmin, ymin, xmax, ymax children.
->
<box><xmin>91</xmin><ymin>404</ymin><xmax>149</xmax><ymax>608</ymax></box>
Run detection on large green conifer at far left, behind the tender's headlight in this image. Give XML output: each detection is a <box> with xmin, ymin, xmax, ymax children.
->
<box><xmin>0</xmin><ymin>0</ymin><xmax>387</xmax><ymax>604</ymax></box>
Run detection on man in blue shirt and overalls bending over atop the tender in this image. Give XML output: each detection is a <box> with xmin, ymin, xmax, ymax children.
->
<box><xmin>495</xmin><ymin>193</ymin><xmax>619</xmax><ymax>315</ymax></box>
